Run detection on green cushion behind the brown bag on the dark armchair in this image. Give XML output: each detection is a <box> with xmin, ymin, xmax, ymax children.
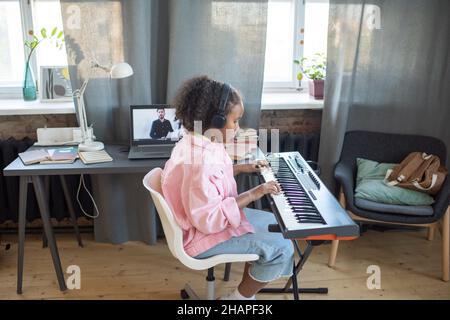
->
<box><xmin>355</xmin><ymin>158</ymin><xmax>434</xmax><ymax>206</ymax></box>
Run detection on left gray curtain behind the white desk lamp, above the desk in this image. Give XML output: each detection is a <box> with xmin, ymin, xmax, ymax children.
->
<box><xmin>61</xmin><ymin>0</ymin><xmax>168</xmax><ymax>144</ymax></box>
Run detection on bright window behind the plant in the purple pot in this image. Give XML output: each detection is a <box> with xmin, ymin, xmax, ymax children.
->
<box><xmin>264</xmin><ymin>0</ymin><xmax>329</xmax><ymax>91</ymax></box>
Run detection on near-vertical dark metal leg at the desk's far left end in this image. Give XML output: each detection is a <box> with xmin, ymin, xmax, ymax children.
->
<box><xmin>17</xmin><ymin>176</ymin><xmax>29</xmax><ymax>294</ymax></box>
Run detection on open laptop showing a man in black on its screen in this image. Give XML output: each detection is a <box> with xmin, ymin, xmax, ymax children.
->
<box><xmin>128</xmin><ymin>104</ymin><xmax>182</xmax><ymax>159</ymax></box>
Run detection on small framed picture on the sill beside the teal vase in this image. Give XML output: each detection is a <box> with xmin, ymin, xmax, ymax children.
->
<box><xmin>39</xmin><ymin>66</ymin><xmax>73</xmax><ymax>102</ymax></box>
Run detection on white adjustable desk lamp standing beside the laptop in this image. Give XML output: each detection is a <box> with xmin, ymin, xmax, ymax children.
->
<box><xmin>73</xmin><ymin>62</ymin><xmax>133</xmax><ymax>151</ymax></box>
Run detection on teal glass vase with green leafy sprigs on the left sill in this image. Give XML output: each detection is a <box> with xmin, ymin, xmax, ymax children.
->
<box><xmin>22</xmin><ymin>27</ymin><xmax>64</xmax><ymax>101</ymax></box>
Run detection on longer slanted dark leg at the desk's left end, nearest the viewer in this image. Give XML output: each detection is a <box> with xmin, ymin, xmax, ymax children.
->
<box><xmin>32</xmin><ymin>176</ymin><xmax>67</xmax><ymax>291</ymax></box>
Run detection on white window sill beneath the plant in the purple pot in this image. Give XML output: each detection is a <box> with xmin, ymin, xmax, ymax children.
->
<box><xmin>261</xmin><ymin>91</ymin><xmax>323</xmax><ymax>110</ymax></box>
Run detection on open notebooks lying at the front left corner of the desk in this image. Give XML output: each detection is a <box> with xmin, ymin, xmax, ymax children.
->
<box><xmin>19</xmin><ymin>147</ymin><xmax>78</xmax><ymax>165</ymax></box>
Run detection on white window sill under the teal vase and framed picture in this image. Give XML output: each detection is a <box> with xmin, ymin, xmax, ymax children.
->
<box><xmin>0</xmin><ymin>99</ymin><xmax>75</xmax><ymax>116</ymax></box>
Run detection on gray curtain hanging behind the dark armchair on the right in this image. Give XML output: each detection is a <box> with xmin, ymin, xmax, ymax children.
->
<box><xmin>319</xmin><ymin>0</ymin><xmax>450</xmax><ymax>188</ymax></box>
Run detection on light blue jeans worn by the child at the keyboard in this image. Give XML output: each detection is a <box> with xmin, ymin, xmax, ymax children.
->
<box><xmin>195</xmin><ymin>208</ymin><xmax>294</xmax><ymax>282</ymax></box>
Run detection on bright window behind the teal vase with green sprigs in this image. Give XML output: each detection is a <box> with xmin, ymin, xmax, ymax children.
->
<box><xmin>0</xmin><ymin>0</ymin><xmax>67</xmax><ymax>98</ymax></box>
